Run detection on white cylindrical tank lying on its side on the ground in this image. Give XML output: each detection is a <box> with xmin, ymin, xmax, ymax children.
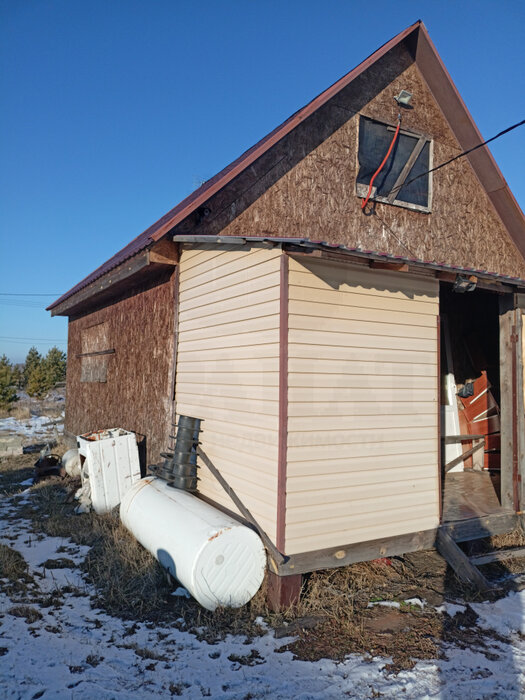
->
<box><xmin>120</xmin><ymin>476</ymin><xmax>266</xmax><ymax>610</ymax></box>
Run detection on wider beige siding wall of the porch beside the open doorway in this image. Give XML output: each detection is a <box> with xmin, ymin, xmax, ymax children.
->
<box><xmin>286</xmin><ymin>257</ymin><xmax>439</xmax><ymax>554</ymax></box>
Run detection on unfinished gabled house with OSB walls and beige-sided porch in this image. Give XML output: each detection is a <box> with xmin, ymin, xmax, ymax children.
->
<box><xmin>49</xmin><ymin>22</ymin><xmax>525</xmax><ymax>600</ymax></box>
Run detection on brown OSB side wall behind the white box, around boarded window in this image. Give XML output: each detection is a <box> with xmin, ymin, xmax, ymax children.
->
<box><xmin>65</xmin><ymin>268</ymin><xmax>174</xmax><ymax>464</ymax></box>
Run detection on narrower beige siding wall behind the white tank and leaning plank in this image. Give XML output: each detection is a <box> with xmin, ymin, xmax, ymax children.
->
<box><xmin>175</xmin><ymin>246</ymin><xmax>280</xmax><ymax>540</ymax></box>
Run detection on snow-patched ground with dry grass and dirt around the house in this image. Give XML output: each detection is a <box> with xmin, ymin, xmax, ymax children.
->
<box><xmin>0</xmin><ymin>402</ymin><xmax>525</xmax><ymax>700</ymax></box>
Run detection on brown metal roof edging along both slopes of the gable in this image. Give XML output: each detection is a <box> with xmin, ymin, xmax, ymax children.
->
<box><xmin>48</xmin><ymin>20</ymin><xmax>525</xmax><ymax>310</ymax></box>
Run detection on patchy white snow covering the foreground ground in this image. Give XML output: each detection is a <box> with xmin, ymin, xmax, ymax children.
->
<box><xmin>0</xmin><ymin>490</ymin><xmax>525</xmax><ymax>700</ymax></box>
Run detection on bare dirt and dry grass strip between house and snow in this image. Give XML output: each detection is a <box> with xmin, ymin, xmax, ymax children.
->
<box><xmin>0</xmin><ymin>446</ymin><xmax>525</xmax><ymax>672</ymax></box>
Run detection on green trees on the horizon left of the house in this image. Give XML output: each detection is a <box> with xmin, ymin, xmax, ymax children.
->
<box><xmin>0</xmin><ymin>347</ymin><xmax>66</xmax><ymax>409</ymax></box>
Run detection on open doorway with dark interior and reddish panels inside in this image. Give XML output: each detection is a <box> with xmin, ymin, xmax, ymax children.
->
<box><xmin>440</xmin><ymin>283</ymin><xmax>504</xmax><ymax>523</ymax></box>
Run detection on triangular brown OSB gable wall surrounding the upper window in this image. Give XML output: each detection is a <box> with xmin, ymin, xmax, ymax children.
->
<box><xmin>214</xmin><ymin>46</ymin><xmax>525</xmax><ymax>277</ymax></box>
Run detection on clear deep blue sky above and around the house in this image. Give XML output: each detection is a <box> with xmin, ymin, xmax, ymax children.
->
<box><xmin>0</xmin><ymin>0</ymin><xmax>525</xmax><ymax>362</ymax></box>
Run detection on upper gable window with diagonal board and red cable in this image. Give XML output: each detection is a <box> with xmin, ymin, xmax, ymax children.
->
<box><xmin>356</xmin><ymin>117</ymin><xmax>432</xmax><ymax>212</ymax></box>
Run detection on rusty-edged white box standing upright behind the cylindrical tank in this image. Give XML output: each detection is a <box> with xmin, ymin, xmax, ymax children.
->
<box><xmin>77</xmin><ymin>428</ymin><xmax>140</xmax><ymax>513</ymax></box>
